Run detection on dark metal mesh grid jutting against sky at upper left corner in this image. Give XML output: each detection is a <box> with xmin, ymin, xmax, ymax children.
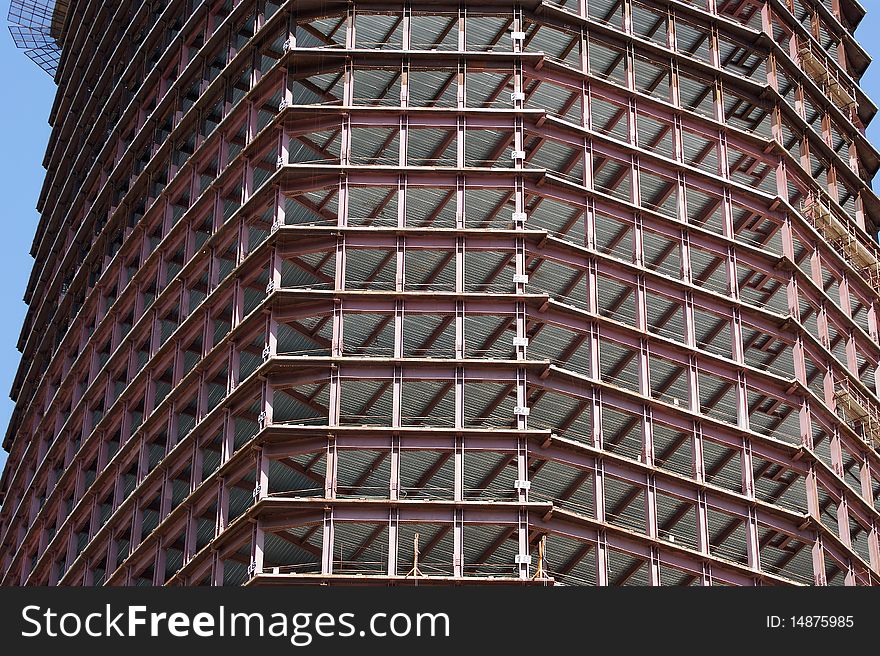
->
<box><xmin>8</xmin><ymin>0</ymin><xmax>70</xmax><ymax>76</ymax></box>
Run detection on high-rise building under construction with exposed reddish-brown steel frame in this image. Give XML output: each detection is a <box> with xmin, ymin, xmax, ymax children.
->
<box><xmin>0</xmin><ymin>0</ymin><xmax>880</xmax><ymax>585</ymax></box>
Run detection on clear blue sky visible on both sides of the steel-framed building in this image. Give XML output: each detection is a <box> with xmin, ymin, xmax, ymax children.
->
<box><xmin>0</xmin><ymin>0</ymin><xmax>880</xmax><ymax>468</ymax></box>
